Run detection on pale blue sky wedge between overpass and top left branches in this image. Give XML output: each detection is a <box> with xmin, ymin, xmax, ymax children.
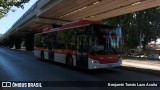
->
<box><xmin>0</xmin><ymin>0</ymin><xmax>37</xmax><ymax>34</ymax></box>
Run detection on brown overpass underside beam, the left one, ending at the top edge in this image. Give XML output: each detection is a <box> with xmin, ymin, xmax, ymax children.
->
<box><xmin>64</xmin><ymin>0</ymin><xmax>139</xmax><ymax>20</ymax></box>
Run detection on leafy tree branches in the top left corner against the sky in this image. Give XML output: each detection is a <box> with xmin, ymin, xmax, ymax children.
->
<box><xmin>0</xmin><ymin>0</ymin><xmax>30</xmax><ymax>18</ymax></box>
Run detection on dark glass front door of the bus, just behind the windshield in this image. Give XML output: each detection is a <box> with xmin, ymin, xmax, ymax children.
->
<box><xmin>76</xmin><ymin>34</ymin><xmax>89</xmax><ymax>68</ymax></box>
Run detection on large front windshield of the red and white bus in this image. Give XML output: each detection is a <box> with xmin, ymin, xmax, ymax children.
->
<box><xmin>90</xmin><ymin>27</ymin><xmax>121</xmax><ymax>54</ymax></box>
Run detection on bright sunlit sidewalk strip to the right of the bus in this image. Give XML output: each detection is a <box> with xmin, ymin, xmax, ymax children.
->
<box><xmin>122</xmin><ymin>58</ymin><xmax>160</xmax><ymax>75</ymax></box>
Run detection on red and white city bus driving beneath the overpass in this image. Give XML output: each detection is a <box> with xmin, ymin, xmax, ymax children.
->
<box><xmin>34</xmin><ymin>20</ymin><xmax>122</xmax><ymax>69</ymax></box>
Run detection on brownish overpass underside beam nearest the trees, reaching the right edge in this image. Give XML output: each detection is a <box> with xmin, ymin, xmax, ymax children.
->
<box><xmin>87</xmin><ymin>0</ymin><xmax>160</xmax><ymax>20</ymax></box>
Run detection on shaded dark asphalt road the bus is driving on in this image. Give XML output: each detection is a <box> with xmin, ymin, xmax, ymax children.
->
<box><xmin>0</xmin><ymin>48</ymin><xmax>160</xmax><ymax>90</ymax></box>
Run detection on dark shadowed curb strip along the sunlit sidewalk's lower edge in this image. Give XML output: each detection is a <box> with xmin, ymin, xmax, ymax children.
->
<box><xmin>121</xmin><ymin>66</ymin><xmax>160</xmax><ymax>76</ymax></box>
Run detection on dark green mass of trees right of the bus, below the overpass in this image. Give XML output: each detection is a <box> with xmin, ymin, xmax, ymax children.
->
<box><xmin>103</xmin><ymin>7</ymin><xmax>160</xmax><ymax>49</ymax></box>
